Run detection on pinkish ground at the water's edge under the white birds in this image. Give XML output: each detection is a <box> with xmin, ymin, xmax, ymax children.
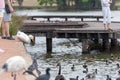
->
<box><xmin>0</xmin><ymin>39</ymin><xmax>34</xmax><ymax>80</ymax></box>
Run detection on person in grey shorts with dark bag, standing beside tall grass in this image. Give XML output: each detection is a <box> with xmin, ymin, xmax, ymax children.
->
<box><xmin>2</xmin><ymin>0</ymin><xmax>14</xmax><ymax>40</ymax></box>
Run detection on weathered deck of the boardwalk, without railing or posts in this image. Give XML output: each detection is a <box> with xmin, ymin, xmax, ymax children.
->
<box><xmin>22</xmin><ymin>20</ymin><xmax>120</xmax><ymax>37</ymax></box>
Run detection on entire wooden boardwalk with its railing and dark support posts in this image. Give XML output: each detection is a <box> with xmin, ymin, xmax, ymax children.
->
<box><xmin>21</xmin><ymin>16</ymin><xmax>120</xmax><ymax>52</ymax></box>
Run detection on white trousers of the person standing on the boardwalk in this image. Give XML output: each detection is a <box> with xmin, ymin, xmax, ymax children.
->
<box><xmin>102</xmin><ymin>7</ymin><xmax>111</xmax><ymax>24</ymax></box>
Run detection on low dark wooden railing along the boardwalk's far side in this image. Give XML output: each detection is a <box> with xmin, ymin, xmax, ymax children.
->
<box><xmin>27</xmin><ymin>15</ymin><xmax>103</xmax><ymax>21</ymax></box>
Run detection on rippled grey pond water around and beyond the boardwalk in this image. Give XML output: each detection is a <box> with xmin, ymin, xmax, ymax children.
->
<box><xmin>15</xmin><ymin>10</ymin><xmax>120</xmax><ymax>80</ymax></box>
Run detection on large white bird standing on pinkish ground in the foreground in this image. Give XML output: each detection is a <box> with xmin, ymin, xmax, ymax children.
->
<box><xmin>0</xmin><ymin>56</ymin><xmax>26</xmax><ymax>80</ymax></box>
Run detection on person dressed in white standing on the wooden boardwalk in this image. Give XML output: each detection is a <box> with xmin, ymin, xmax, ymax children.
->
<box><xmin>101</xmin><ymin>0</ymin><xmax>112</xmax><ymax>30</ymax></box>
